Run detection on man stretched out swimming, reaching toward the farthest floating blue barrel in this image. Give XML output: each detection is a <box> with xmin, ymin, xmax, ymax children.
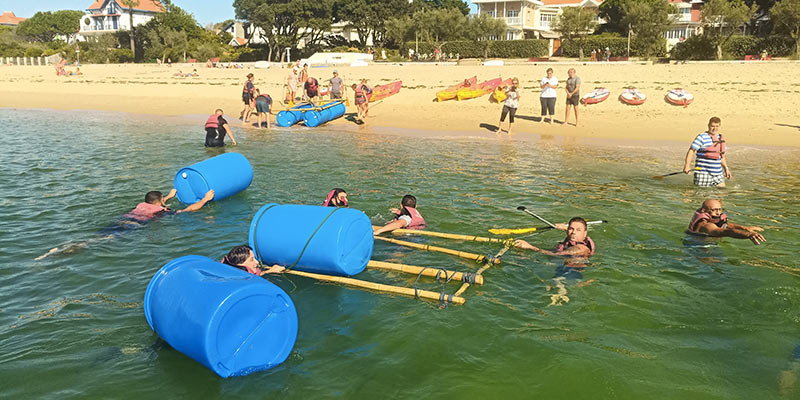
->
<box><xmin>34</xmin><ymin>189</ymin><xmax>214</xmax><ymax>261</ymax></box>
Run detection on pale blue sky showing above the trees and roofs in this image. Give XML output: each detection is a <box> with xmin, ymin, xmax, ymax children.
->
<box><xmin>0</xmin><ymin>0</ymin><xmax>475</xmax><ymax>25</ymax></box>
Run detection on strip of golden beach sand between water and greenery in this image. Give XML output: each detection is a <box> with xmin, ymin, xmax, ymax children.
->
<box><xmin>0</xmin><ymin>62</ymin><xmax>800</xmax><ymax>147</ymax></box>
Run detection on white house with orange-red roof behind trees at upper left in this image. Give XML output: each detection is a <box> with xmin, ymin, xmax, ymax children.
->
<box><xmin>79</xmin><ymin>0</ymin><xmax>165</xmax><ymax>35</ymax></box>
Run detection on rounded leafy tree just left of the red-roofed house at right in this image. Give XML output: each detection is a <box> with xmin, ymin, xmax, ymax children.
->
<box><xmin>622</xmin><ymin>0</ymin><xmax>678</xmax><ymax>57</ymax></box>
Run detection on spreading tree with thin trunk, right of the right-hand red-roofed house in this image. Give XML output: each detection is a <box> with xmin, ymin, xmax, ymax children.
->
<box><xmin>700</xmin><ymin>0</ymin><xmax>755</xmax><ymax>60</ymax></box>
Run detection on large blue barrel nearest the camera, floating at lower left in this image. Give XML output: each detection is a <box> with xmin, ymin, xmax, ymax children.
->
<box><xmin>144</xmin><ymin>256</ymin><xmax>297</xmax><ymax>378</ymax></box>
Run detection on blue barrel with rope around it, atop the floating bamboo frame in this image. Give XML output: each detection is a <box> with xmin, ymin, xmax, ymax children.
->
<box><xmin>250</xmin><ymin>204</ymin><xmax>374</xmax><ymax>276</ymax></box>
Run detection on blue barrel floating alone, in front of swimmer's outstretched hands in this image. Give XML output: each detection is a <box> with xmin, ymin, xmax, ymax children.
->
<box><xmin>173</xmin><ymin>153</ymin><xmax>253</xmax><ymax>204</ymax></box>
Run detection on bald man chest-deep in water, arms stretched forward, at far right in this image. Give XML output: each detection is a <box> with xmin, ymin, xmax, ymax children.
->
<box><xmin>688</xmin><ymin>199</ymin><xmax>767</xmax><ymax>244</ymax></box>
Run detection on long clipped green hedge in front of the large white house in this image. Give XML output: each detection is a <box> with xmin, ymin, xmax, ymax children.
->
<box><xmin>405</xmin><ymin>39</ymin><xmax>548</xmax><ymax>58</ymax></box>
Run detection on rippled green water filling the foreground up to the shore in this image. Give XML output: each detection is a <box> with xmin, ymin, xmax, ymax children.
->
<box><xmin>0</xmin><ymin>109</ymin><xmax>800</xmax><ymax>399</ymax></box>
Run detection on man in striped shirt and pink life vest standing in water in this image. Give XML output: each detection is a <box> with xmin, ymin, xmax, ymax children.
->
<box><xmin>683</xmin><ymin>117</ymin><xmax>732</xmax><ymax>187</ymax></box>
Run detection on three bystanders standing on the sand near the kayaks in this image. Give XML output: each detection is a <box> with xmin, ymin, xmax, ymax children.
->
<box><xmin>496</xmin><ymin>68</ymin><xmax>581</xmax><ymax>134</ymax></box>
